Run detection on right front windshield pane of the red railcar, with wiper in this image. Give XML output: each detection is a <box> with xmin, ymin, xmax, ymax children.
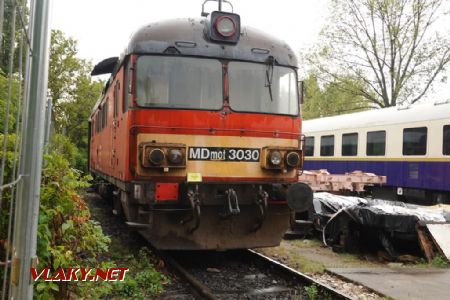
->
<box><xmin>228</xmin><ymin>61</ymin><xmax>299</xmax><ymax>115</ymax></box>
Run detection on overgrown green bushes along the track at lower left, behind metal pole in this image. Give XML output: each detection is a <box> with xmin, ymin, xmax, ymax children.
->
<box><xmin>0</xmin><ymin>134</ymin><xmax>169</xmax><ymax>299</ymax></box>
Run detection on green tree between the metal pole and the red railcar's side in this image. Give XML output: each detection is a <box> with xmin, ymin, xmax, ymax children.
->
<box><xmin>49</xmin><ymin>30</ymin><xmax>103</xmax><ymax>170</ymax></box>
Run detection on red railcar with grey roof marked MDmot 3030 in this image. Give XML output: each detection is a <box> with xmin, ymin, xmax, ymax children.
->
<box><xmin>89</xmin><ymin>1</ymin><xmax>312</xmax><ymax>250</ymax></box>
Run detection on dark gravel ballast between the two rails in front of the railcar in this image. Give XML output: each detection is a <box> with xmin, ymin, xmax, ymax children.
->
<box><xmin>173</xmin><ymin>251</ymin><xmax>338</xmax><ymax>299</ymax></box>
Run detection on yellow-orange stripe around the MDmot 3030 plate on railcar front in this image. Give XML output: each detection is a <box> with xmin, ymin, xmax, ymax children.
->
<box><xmin>137</xmin><ymin>133</ymin><xmax>298</xmax><ymax>179</ymax></box>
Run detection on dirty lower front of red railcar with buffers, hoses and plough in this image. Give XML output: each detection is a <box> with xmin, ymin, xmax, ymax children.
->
<box><xmin>98</xmin><ymin>181</ymin><xmax>312</xmax><ymax>250</ymax></box>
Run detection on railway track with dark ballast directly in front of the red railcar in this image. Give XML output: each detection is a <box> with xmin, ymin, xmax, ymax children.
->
<box><xmin>158</xmin><ymin>250</ymin><xmax>351</xmax><ymax>300</ymax></box>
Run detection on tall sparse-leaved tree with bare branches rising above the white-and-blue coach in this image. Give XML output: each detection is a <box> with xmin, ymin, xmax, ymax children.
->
<box><xmin>308</xmin><ymin>0</ymin><xmax>450</xmax><ymax>107</ymax></box>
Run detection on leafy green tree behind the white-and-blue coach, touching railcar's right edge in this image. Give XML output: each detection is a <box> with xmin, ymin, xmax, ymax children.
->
<box><xmin>302</xmin><ymin>74</ymin><xmax>370</xmax><ymax>120</ymax></box>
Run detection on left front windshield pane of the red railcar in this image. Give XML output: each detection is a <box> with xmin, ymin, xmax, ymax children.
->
<box><xmin>136</xmin><ymin>56</ymin><xmax>223</xmax><ymax>110</ymax></box>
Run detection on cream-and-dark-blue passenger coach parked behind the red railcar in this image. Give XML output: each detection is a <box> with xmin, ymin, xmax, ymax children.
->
<box><xmin>303</xmin><ymin>101</ymin><xmax>450</xmax><ymax>204</ymax></box>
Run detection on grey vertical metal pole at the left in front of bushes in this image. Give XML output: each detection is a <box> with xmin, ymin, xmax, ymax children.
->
<box><xmin>11</xmin><ymin>0</ymin><xmax>50</xmax><ymax>300</ymax></box>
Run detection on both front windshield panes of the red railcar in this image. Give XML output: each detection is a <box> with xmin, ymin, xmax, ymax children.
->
<box><xmin>136</xmin><ymin>56</ymin><xmax>299</xmax><ymax>115</ymax></box>
